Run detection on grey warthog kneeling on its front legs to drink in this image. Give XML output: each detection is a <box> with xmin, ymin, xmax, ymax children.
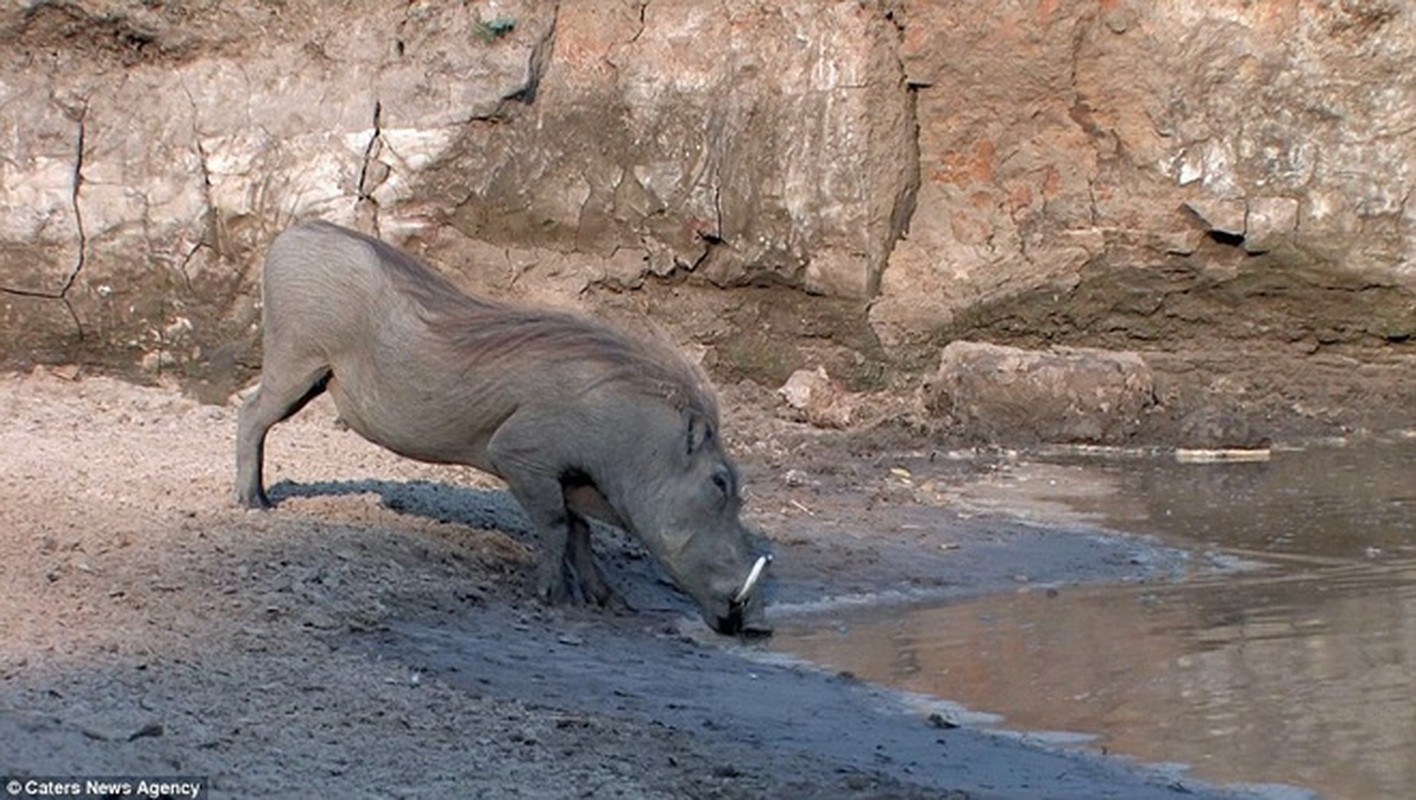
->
<box><xmin>236</xmin><ymin>222</ymin><xmax>770</xmax><ymax>634</ymax></box>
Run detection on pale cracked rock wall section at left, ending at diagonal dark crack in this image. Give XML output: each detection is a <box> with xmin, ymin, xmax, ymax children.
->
<box><xmin>0</xmin><ymin>1</ymin><xmax>555</xmax><ymax>393</ymax></box>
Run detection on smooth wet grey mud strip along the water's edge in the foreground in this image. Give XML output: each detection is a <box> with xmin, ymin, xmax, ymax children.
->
<box><xmin>357</xmin><ymin>603</ymin><xmax>1222</xmax><ymax>799</ymax></box>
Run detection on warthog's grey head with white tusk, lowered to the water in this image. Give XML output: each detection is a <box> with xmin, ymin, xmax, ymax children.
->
<box><xmin>634</xmin><ymin>412</ymin><xmax>772</xmax><ymax>636</ymax></box>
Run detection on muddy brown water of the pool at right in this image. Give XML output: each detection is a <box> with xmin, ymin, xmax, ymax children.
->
<box><xmin>775</xmin><ymin>440</ymin><xmax>1416</xmax><ymax>799</ymax></box>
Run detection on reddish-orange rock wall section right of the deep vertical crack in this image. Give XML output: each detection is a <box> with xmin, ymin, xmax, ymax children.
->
<box><xmin>872</xmin><ymin>0</ymin><xmax>1416</xmax><ymax>349</ymax></box>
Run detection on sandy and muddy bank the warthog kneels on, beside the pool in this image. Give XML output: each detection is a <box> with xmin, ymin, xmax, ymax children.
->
<box><xmin>0</xmin><ymin>370</ymin><xmax>1263</xmax><ymax>799</ymax></box>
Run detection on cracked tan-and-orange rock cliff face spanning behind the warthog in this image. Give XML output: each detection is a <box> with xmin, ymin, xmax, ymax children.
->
<box><xmin>0</xmin><ymin>0</ymin><xmax>1416</xmax><ymax>436</ymax></box>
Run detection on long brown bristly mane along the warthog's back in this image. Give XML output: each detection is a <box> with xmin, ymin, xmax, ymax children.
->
<box><xmin>344</xmin><ymin>223</ymin><xmax>718</xmax><ymax>423</ymax></box>
